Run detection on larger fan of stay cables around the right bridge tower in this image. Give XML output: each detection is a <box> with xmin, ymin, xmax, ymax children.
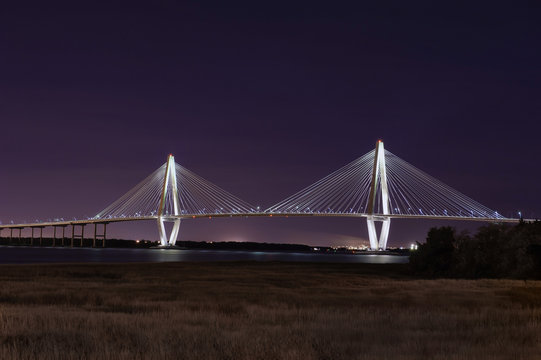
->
<box><xmin>266</xmin><ymin>150</ymin><xmax>504</xmax><ymax>219</ymax></box>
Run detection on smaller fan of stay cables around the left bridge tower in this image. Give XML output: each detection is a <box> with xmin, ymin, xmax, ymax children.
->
<box><xmin>94</xmin><ymin>163</ymin><xmax>254</xmax><ymax>219</ymax></box>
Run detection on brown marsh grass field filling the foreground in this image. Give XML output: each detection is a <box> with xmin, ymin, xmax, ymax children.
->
<box><xmin>0</xmin><ymin>263</ymin><xmax>541</xmax><ymax>359</ymax></box>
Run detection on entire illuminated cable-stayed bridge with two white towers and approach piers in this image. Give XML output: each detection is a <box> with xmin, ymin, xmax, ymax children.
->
<box><xmin>0</xmin><ymin>140</ymin><xmax>531</xmax><ymax>250</ymax></box>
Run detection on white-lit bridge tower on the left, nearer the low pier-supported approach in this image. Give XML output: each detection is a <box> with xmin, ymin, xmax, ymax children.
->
<box><xmin>158</xmin><ymin>154</ymin><xmax>180</xmax><ymax>246</ymax></box>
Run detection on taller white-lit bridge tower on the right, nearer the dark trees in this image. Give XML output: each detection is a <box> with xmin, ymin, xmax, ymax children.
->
<box><xmin>366</xmin><ymin>140</ymin><xmax>391</xmax><ymax>250</ymax></box>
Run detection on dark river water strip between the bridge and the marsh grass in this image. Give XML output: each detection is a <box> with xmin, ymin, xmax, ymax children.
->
<box><xmin>0</xmin><ymin>246</ymin><xmax>408</xmax><ymax>264</ymax></box>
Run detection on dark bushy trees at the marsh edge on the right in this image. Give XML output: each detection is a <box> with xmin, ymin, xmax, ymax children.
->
<box><xmin>410</xmin><ymin>221</ymin><xmax>541</xmax><ymax>278</ymax></box>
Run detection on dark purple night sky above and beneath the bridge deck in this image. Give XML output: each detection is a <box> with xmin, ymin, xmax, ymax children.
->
<box><xmin>0</xmin><ymin>1</ymin><xmax>541</xmax><ymax>246</ymax></box>
